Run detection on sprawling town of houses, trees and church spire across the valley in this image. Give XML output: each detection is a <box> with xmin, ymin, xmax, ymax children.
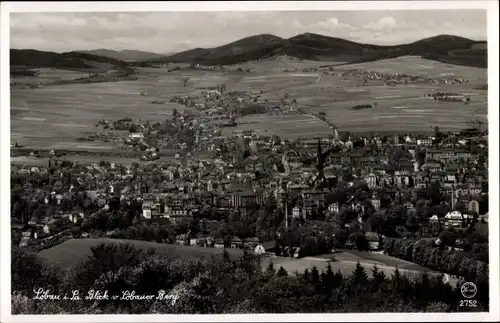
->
<box><xmin>11</xmin><ymin>101</ymin><xmax>488</xmax><ymax>266</ymax></box>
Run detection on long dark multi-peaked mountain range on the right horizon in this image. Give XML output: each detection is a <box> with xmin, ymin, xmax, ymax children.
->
<box><xmin>141</xmin><ymin>33</ymin><xmax>487</xmax><ymax>68</ymax></box>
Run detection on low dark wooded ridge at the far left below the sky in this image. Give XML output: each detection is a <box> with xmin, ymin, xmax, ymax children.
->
<box><xmin>10</xmin><ymin>49</ymin><xmax>129</xmax><ymax>71</ymax></box>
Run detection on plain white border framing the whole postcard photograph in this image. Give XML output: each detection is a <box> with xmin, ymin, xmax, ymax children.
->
<box><xmin>0</xmin><ymin>0</ymin><xmax>500</xmax><ymax>323</ymax></box>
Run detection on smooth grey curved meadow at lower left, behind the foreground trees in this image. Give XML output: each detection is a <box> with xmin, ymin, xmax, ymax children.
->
<box><xmin>38</xmin><ymin>238</ymin><xmax>243</xmax><ymax>268</ymax></box>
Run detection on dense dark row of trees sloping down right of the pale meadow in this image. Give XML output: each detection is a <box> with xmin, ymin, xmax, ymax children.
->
<box><xmin>384</xmin><ymin>238</ymin><xmax>489</xmax><ymax>281</ymax></box>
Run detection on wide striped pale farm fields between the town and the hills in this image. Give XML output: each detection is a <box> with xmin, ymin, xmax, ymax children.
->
<box><xmin>10</xmin><ymin>57</ymin><xmax>487</xmax><ymax>151</ymax></box>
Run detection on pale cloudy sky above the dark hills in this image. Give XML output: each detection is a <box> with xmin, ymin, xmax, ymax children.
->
<box><xmin>10</xmin><ymin>9</ymin><xmax>487</xmax><ymax>53</ymax></box>
